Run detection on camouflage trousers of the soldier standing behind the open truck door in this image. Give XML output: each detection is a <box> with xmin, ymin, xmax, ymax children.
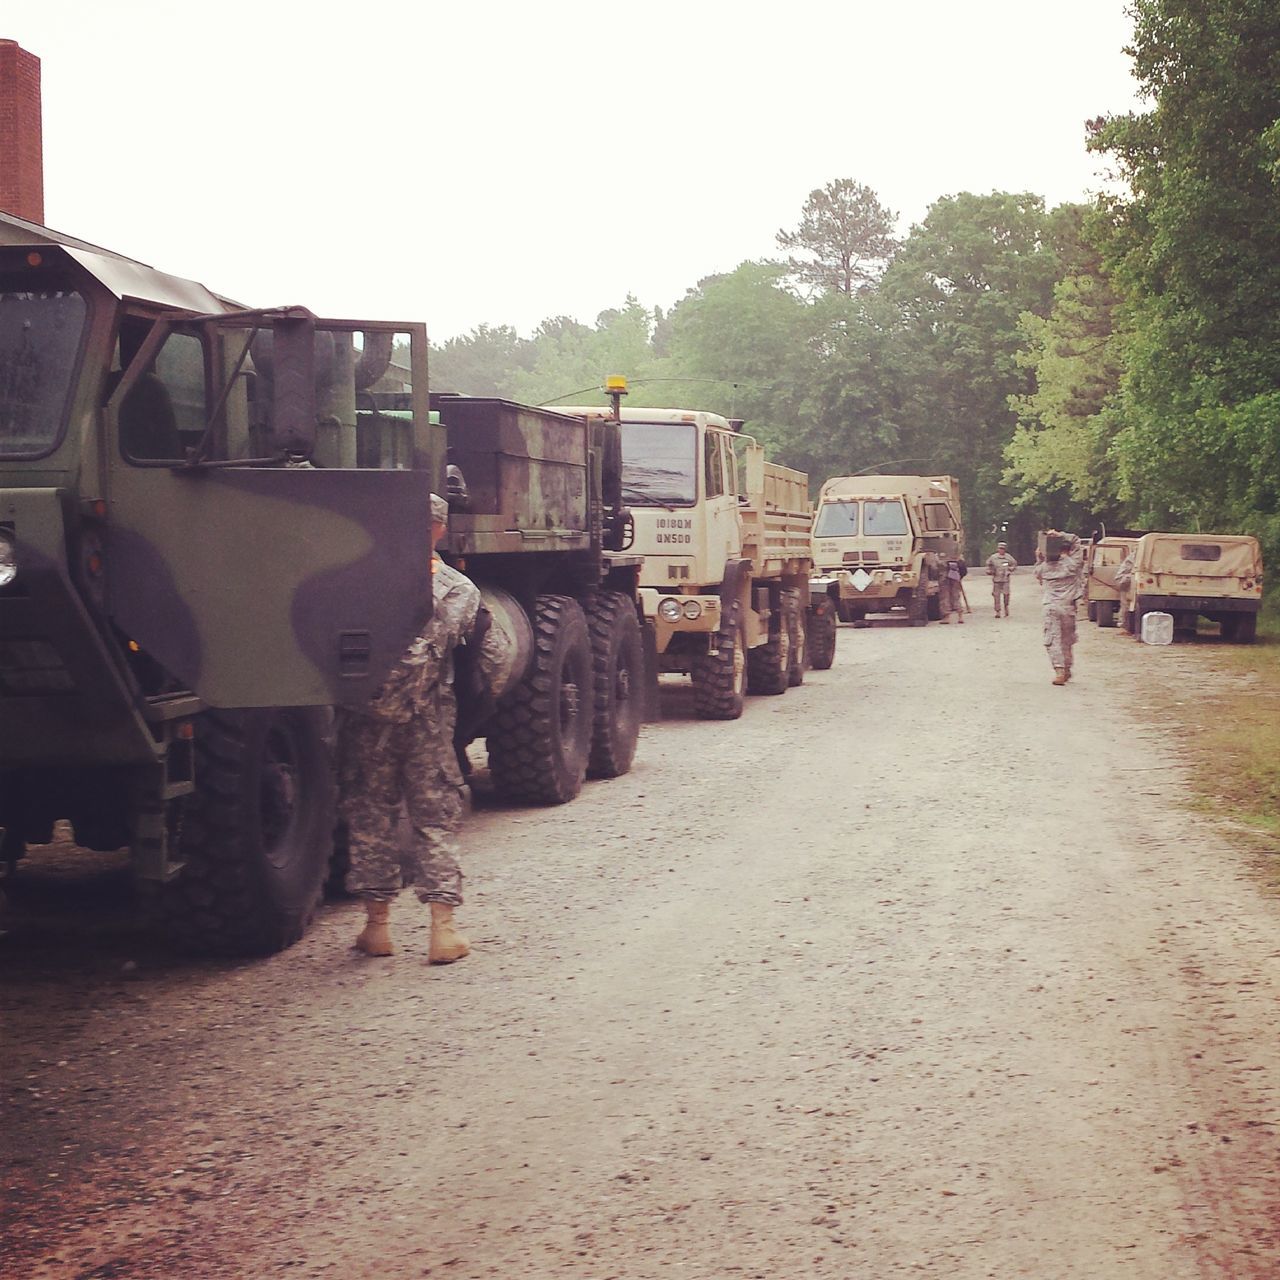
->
<box><xmin>338</xmin><ymin>714</ymin><xmax>462</xmax><ymax>906</ymax></box>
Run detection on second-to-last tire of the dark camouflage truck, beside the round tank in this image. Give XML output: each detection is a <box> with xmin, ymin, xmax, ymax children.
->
<box><xmin>486</xmin><ymin>595</ymin><xmax>595</xmax><ymax>804</ymax></box>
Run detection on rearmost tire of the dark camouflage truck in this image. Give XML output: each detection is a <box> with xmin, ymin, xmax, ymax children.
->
<box><xmin>586</xmin><ymin>591</ymin><xmax>644</xmax><ymax>778</ymax></box>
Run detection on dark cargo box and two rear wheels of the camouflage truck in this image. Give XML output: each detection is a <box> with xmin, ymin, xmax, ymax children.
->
<box><xmin>419</xmin><ymin>394</ymin><xmax>650</xmax><ymax>804</ymax></box>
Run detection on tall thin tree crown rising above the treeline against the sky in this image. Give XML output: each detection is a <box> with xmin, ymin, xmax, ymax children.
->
<box><xmin>777</xmin><ymin>178</ymin><xmax>897</xmax><ymax>296</ymax></box>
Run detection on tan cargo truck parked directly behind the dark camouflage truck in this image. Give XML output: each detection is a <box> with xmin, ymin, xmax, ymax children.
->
<box><xmin>561</xmin><ymin>396</ymin><xmax>835</xmax><ymax>719</ymax></box>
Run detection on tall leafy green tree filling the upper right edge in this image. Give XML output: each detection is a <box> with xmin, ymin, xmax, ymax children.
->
<box><xmin>1091</xmin><ymin>0</ymin><xmax>1280</xmax><ymax>557</ymax></box>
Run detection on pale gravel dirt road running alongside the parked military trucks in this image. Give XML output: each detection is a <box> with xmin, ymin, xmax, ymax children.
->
<box><xmin>0</xmin><ymin>593</ymin><xmax>1280</xmax><ymax>1280</ymax></box>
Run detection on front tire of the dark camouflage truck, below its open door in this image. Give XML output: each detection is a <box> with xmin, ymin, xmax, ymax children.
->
<box><xmin>159</xmin><ymin>708</ymin><xmax>335</xmax><ymax>955</ymax></box>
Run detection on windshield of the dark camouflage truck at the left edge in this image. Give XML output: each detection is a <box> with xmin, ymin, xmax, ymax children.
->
<box><xmin>0</xmin><ymin>283</ymin><xmax>87</xmax><ymax>458</ymax></box>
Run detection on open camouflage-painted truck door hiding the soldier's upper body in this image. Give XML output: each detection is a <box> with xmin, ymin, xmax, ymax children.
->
<box><xmin>102</xmin><ymin>315</ymin><xmax>440</xmax><ymax>707</ymax></box>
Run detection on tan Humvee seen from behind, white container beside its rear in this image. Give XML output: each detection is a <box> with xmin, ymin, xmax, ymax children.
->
<box><xmin>1120</xmin><ymin>534</ymin><xmax>1262</xmax><ymax>644</ymax></box>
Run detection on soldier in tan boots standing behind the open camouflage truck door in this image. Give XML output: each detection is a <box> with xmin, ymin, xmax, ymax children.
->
<box><xmin>338</xmin><ymin>494</ymin><xmax>481</xmax><ymax>964</ymax></box>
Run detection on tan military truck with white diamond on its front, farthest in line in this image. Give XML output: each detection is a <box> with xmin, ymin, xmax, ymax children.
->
<box><xmin>813</xmin><ymin>476</ymin><xmax>964</xmax><ymax>626</ymax></box>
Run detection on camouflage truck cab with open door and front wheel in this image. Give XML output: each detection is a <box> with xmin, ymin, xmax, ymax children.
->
<box><xmin>0</xmin><ymin>218</ymin><xmax>444</xmax><ymax>952</ymax></box>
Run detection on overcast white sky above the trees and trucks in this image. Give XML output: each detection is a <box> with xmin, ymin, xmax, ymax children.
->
<box><xmin>10</xmin><ymin>0</ymin><xmax>1137</xmax><ymax>340</ymax></box>
